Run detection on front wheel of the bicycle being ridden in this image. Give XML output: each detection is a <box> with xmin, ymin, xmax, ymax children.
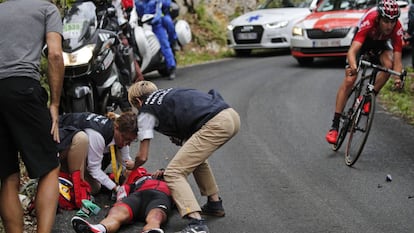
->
<box><xmin>345</xmin><ymin>93</ymin><xmax>375</xmax><ymax>166</ymax></box>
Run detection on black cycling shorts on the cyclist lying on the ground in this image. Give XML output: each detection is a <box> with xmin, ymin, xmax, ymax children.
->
<box><xmin>116</xmin><ymin>189</ymin><xmax>172</xmax><ymax>222</ymax></box>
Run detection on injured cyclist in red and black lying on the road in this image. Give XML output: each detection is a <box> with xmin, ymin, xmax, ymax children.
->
<box><xmin>72</xmin><ymin>167</ymin><xmax>172</xmax><ymax>233</ymax></box>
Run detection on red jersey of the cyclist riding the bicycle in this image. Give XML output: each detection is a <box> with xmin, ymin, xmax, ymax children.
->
<box><xmin>354</xmin><ymin>7</ymin><xmax>403</xmax><ymax>52</ymax></box>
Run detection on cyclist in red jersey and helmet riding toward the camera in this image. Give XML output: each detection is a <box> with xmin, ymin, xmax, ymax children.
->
<box><xmin>326</xmin><ymin>0</ymin><xmax>403</xmax><ymax>144</ymax></box>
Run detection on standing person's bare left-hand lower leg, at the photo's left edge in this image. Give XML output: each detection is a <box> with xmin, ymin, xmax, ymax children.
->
<box><xmin>0</xmin><ymin>173</ymin><xmax>23</xmax><ymax>233</ymax></box>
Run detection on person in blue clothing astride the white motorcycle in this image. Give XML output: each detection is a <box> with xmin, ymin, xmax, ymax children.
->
<box><xmin>135</xmin><ymin>0</ymin><xmax>176</xmax><ymax>80</ymax></box>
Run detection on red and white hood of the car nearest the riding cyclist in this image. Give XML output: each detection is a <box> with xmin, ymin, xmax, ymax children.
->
<box><xmin>298</xmin><ymin>10</ymin><xmax>367</xmax><ymax>30</ymax></box>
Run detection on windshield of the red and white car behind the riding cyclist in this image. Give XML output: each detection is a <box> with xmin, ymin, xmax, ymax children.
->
<box><xmin>316</xmin><ymin>0</ymin><xmax>376</xmax><ymax>12</ymax></box>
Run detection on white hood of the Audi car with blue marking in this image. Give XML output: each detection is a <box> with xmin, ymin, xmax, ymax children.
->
<box><xmin>231</xmin><ymin>8</ymin><xmax>311</xmax><ymax>25</ymax></box>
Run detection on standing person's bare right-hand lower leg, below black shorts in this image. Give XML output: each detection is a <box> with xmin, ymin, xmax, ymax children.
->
<box><xmin>36</xmin><ymin>167</ymin><xmax>60</xmax><ymax>233</ymax></box>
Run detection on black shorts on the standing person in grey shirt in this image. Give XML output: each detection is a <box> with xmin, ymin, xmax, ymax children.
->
<box><xmin>0</xmin><ymin>77</ymin><xmax>59</xmax><ymax>178</ymax></box>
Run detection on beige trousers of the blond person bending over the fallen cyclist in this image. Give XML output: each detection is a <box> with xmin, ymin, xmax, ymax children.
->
<box><xmin>164</xmin><ymin>108</ymin><xmax>240</xmax><ymax>217</ymax></box>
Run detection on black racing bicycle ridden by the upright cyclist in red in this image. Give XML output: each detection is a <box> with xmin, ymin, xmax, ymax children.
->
<box><xmin>332</xmin><ymin>56</ymin><xmax>407</xmax><ymax>166</ymax></box>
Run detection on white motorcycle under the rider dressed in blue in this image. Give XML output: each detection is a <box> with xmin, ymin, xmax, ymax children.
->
<box><xmin>129</xmin><ymin>3</ymin><xmax>192</xmax><ymax>76</ymax></box>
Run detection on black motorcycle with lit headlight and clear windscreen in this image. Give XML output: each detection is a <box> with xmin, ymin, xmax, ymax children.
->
<box><xmin>61</xmin><ymin>1</ymin><xmax>126</xmax><ymax>114</ymax></box>
